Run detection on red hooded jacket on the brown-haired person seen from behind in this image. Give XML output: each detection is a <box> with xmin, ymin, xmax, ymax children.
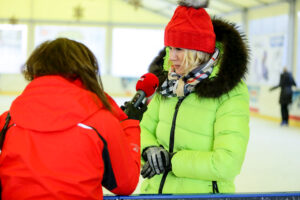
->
<box><xmin>0</xmin><ymin>76</ymin><xmax>140</xmax><ymax>200</ymax></box>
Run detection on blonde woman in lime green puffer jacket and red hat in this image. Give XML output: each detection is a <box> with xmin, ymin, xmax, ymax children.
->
<box><xmin>141</xmin><ymin>1</ymin><xmax>249</xmax><ymax>194</ymax></box>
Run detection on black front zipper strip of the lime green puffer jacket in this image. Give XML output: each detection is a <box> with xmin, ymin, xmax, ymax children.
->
<box><xmin>158</xmin><ymin>97</ymin><xmax>185</xmax><ymax>194</ymax></box>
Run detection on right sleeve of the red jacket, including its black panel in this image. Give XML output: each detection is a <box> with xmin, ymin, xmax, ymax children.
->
<box><xmin>97</xmin><ymin>97</ymin><xmax>140</xmax><ymax>195</ymax></box>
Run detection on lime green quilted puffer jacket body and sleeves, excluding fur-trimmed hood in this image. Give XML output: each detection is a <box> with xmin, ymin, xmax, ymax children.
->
<box><xmin>141</xmin><ymin>82</ymin><xmax>249</xmax><ymax>194</ymax></box>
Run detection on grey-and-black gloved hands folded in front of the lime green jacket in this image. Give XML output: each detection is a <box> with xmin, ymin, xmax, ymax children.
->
<box><xmin>142</xmin><ymin>147</ymin><xmax>172</xmax><ymax>176</ymax></box>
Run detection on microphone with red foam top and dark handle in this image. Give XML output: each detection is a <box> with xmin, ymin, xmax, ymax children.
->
<box><xmin>130</xmin><ymin>73</ymin><xmax>159</xmax><ymax>108</ymax></box>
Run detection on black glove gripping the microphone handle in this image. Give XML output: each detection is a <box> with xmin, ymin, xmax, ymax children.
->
<box><xmin>121</xmin><ymin>101</ymin><xmax>147</xmax><ymax>121</ymax></box>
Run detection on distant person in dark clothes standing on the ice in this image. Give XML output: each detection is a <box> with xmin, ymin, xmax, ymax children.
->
<box><xmin>270</xmin><ymin>67</ymin><xmax>296</xmax><ymax>126</ymax></box>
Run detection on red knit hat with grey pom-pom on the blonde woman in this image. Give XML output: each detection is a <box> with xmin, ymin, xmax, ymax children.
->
<box><xmin>165</xmin><ymin>0</ymin><xmax>216</xmax><ymax>53</ymax></box>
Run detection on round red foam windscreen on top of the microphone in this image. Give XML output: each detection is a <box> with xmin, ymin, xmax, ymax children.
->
<box><xmin>135</xmin><ymin>73</ymin><xmax>159</xmax><ymax>97</ymax></box>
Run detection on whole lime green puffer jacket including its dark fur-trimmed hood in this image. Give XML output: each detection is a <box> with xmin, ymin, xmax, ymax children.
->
<box><xmin>140</xmin><ymin>19</ymin><xmax>249</xmax><ymax>194</ymax></box>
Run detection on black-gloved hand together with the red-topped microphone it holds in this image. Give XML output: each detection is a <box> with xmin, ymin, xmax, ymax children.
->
<box><xmin>121</xmin><ymin>73</ymin><xmax>158</xmax><ymax>121</ymax></box>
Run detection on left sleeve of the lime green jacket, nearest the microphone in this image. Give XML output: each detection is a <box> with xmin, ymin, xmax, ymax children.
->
<box><xmin>141</xmin><ymin>95</ymin><xmax>160</xmax><ymax>162</ymax></box>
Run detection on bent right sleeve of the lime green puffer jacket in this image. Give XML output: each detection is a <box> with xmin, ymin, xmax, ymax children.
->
<box><xmin>172</xmin><ymin>85</ymin><xmax>249</xmax><ymax>181</ymax></box>
